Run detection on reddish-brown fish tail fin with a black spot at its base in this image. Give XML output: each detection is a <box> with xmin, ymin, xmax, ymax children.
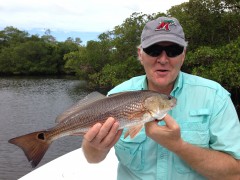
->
<box><xmin>8</xmin><ymin>131</ymin><xmax>52</xmax><ymax>168</ymax></box>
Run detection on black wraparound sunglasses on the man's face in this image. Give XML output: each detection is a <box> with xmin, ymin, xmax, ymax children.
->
<box><xmin>143</xmin><ymin>44</ymin><xmax>184</xmax><ymax>57</ymax></box>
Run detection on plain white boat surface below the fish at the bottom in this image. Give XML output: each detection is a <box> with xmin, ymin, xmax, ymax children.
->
<box><xmin>19</xmin><ymin>148</ymin><xmax>118</xmax><ymax>180</ymax></box>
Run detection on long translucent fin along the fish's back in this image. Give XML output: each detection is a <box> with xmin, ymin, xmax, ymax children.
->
<box><xmin>56</xmin><ymin>91</ymin><xmax>106</xmax><ymax>123</ymax></box>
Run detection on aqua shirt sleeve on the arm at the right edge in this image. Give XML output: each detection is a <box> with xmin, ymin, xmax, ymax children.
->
<box><xmin>210</xmin><ymin>95</ymin><xmax>240</xmax><ymax>159</ymax></box>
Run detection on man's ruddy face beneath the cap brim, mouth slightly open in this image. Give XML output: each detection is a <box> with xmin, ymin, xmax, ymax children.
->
<box><xmin>138</xmin><ymin>42</ymin><xmax>185</xmax><ymax>94</ymax></box>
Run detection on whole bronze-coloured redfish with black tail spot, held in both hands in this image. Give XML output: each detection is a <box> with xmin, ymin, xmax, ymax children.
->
<box><xmin>9</xmin><ymin>90</ymin><xmax>176</xmax><ymax>167</ymax></box>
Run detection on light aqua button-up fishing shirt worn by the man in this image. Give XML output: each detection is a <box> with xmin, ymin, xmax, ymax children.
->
<box><xmin>108</xmin><ymin>72</ymin><xmax>240</xmax><ymax>180</ymax></box>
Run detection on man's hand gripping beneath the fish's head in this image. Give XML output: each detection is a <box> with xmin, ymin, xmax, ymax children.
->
<box><xmin>145</xmin><ymin>115</ymin><xmax>184</xmax><ymax>152</ymax></box>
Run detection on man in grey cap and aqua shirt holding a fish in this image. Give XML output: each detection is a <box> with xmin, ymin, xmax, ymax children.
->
<box><xmin>82</xmin><ymin>17</ymin><xmax>240</xmax><ymax>180</ymax></box>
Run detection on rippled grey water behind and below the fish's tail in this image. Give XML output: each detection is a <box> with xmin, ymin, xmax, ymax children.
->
<box><xmin>0</xmin><ymin>78</ymin><xmax>89</xmax><ymax>180</ymax></box>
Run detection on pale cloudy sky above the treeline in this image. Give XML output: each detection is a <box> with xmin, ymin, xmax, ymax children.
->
<box><xmin>0</xmin><ymin>0</ymin><xmax>188</xmax><ymax>41</ymax></box>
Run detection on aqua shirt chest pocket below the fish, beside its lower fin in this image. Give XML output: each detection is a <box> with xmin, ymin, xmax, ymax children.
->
<box><xmin>115</xmin><ymin>131</ymin><xmax>147</xmax><ymax>170</ymax></box>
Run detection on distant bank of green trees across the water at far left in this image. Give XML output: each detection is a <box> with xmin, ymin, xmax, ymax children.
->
<box><xmin>0</xmin><ymin>27</ymin><xmax>79</xmax><ymax>75</ymax></box>
